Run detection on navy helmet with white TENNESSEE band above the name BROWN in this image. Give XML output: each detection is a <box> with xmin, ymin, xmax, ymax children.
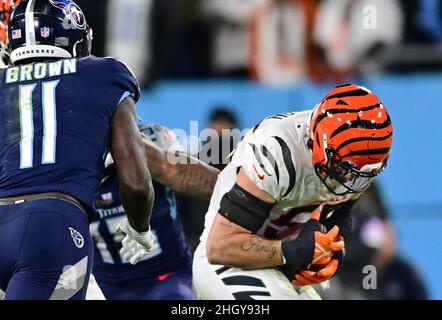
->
<box><xmin>8</xmin><ymin>0</ymin><xmax>92</xmax><ymax>64</ymax></box>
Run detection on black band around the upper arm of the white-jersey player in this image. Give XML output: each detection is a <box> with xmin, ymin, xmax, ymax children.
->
<box><xmin>218</xmin><ymin>184</ymin><xmax>273</xmax><ymax>233</ymax></box>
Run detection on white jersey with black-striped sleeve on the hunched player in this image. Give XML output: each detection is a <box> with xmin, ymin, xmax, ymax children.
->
<box><xmin>200</xmin><ymin>110</ymin><xmax>359</xmax><ymax>244</ymax></box>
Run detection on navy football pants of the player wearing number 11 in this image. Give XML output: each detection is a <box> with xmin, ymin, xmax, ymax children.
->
<box><xmin>0</xmin><ymin>199</ymin><xmax>93</xmax><ymax>300</ymax></box>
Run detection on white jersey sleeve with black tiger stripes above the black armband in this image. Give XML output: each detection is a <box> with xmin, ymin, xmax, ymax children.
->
<box><xmin>241</xmin><ymin>130</ymin><xmax>291</xmax><ymax>201</ymax></box>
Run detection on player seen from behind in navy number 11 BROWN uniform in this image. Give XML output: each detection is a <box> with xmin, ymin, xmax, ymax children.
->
<box><xmin>0</xmin><ymin>0</ymin><xmax>154</xmax><ymax>299</ymax></box>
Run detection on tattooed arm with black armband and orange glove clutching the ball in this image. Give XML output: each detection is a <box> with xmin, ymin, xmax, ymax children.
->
<box><xmin>206</xmin><ymin>168</ymin><xmax>343</xmax><ymax>278</ymax></box>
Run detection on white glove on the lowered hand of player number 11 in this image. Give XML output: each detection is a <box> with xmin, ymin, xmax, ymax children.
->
<box><xmin>116</xmin><ymin>218</ymin><xmax>154</xmax><ymax>265</ymax></box>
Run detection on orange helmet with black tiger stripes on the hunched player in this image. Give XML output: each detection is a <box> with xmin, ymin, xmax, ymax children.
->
<box><xmin>308</xmin><ymin>84</ymin><xmax>393</xmax><ymax>195</ymax></box>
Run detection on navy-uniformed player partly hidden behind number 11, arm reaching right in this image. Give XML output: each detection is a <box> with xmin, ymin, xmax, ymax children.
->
<box><xmin>87</xmin><ymin>125</ymin><xmax>218</xmax><ymax>300</ymax></box>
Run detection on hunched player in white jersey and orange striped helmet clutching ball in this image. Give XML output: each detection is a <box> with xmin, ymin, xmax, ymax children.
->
<box><xmin>193</xmin><ymin>85</ymin><xmax>393</xmax><ymax>299</ymax></box>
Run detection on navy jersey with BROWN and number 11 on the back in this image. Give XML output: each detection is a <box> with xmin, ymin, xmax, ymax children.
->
<box><xmin>0</xmin><ymin>56</ymin><xmax>140</xmax><ymax>212</ymax></box>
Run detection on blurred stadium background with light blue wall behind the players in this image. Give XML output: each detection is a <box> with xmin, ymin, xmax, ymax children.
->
<box><xmin>76</xmin><ymin>0</ymin><xmax>442</xmax><ymax>299</ymax></box>
